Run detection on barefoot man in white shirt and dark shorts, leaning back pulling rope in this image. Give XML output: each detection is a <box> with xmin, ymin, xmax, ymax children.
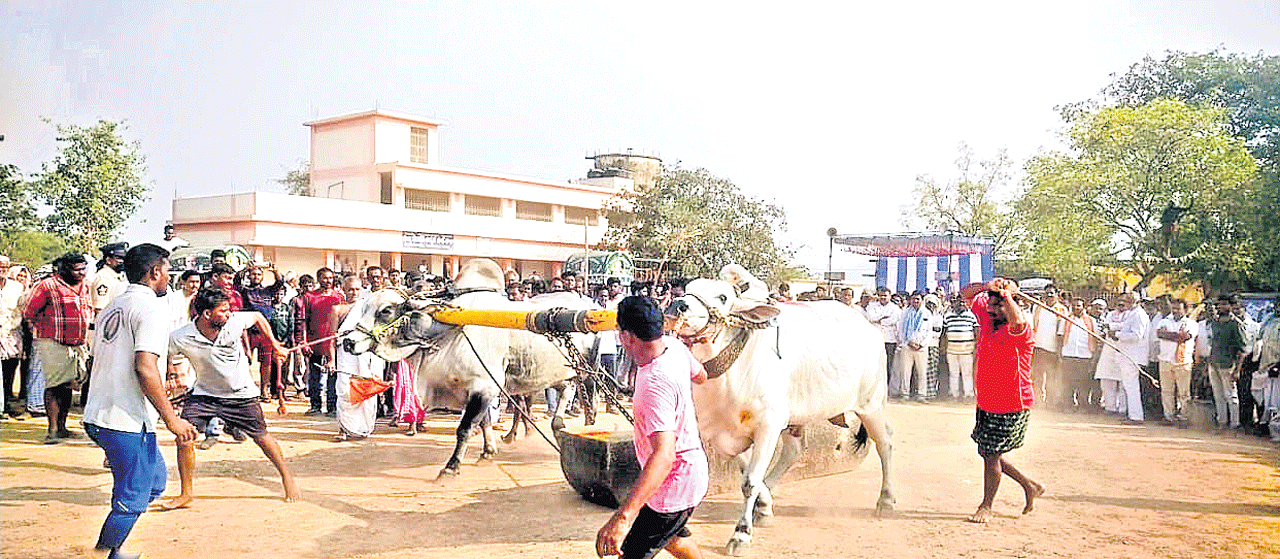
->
<box><xmin>164</xmin><ymin>289</ymin><xmax>300</xmax><ymax>509</ymax></box>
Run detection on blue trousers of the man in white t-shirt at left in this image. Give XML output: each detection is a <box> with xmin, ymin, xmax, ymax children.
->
<box><xmin>84</xmin><ymin>423</ymin><xmax>169</xmax><ymax>549</ymax></box>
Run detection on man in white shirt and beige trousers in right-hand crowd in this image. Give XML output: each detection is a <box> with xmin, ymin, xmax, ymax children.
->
<box><xmin>1155</xmin><ymin>299</ymin><xmax>1199</xmax><ymax>426</ymax></box>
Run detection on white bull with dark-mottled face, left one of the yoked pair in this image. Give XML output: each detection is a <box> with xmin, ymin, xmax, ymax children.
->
<box><xmin>343</xmin><ymin>258</ymin><xmax>595</xmax><ymax>476</ymax></box>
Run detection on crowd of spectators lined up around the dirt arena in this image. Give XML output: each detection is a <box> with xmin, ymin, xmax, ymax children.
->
<box><xmin>0</xmin><ymin>230</ymin><xmax>1280</xmax><ymax>444</ymax></box>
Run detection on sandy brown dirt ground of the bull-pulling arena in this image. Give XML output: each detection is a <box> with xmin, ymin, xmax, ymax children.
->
<box><xmin>0</xmin><ymin>396</ymin><xmax>1280</xmax><ymax>559</ymax></box>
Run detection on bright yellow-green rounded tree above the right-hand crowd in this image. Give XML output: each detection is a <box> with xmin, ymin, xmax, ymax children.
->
<box><xmin>1018</xmin><ymin>100</ymin><xmax>1257</xmax><ymax>288</ymax></box>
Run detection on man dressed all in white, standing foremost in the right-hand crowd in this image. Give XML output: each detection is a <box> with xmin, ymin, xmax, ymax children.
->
<box><xmin>1094</xmin><ymin>293</ymin><xmax>1149</xmax><ymax>423</ymax></box>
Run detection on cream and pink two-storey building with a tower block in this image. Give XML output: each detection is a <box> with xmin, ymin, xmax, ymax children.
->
<box><xmin>173</xmin><ymin>110</ymin><xmax>637</xmax><ymax>278</ymax></box>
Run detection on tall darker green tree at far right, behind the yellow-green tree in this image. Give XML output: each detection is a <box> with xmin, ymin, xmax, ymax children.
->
<box><xmin>1085</xmin><ymin>49</ymin><xmax>1280</xmax><ymax>290</ymax></box>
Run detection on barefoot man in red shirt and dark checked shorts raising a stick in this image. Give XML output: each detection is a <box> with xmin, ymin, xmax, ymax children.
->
<box><xmin>964</xmin><ymin>278</ymin><xmax>1044</xmax><ymax>523</ymax></box>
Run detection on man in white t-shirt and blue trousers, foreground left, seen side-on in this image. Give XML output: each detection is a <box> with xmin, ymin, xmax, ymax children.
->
<box><xmin>84</xmin><ymin>244</ymin><xmax>196</xmax><ymax>556</ymax></box>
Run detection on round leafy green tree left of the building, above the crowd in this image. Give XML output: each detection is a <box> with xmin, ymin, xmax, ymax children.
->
<box><xmin>35</xmin><ymin>120</ymin><xmax>150</xmax><ymax>251</ymax></box>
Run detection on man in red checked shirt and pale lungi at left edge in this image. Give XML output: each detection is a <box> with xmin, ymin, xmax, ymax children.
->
<box><xmin>22</xmin><ymin>252</ymin><xmax>93</xmax><ymax>444</ymax></box>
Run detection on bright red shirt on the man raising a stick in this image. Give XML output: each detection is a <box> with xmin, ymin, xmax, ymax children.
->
<box><xmin>970</xmin><ymin>293</ymin><xmax>1036</xmax><ymax>413</ymax></box>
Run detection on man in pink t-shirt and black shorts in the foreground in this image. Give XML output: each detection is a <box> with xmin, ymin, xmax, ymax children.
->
<box><xmin>595</xmin><ymin>297</ymin><xmax>709</xmax><ymax>559</ymax></box>
